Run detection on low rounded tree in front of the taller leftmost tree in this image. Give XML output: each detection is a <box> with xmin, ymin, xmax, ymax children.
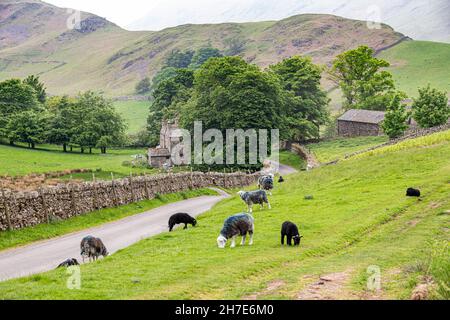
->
<box><xmin>6</xmin><ymin>110</ymin><xmax>47</xmax><ymax>149</ymax></box>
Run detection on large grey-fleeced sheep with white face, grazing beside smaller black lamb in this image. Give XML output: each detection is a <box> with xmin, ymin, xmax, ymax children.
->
<box><xmin>217</xmin><ymin>213</ymin><xmax>255</xmax><ymax>249</ymax></box>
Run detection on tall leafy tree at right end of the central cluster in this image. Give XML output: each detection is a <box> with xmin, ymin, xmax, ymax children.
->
<box><xmin>270</xmin><ymin>56</ymin><xmax>329</xmax><ymax>141</ymax></box>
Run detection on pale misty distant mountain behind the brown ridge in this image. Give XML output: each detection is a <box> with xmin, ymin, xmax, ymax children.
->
<box><xmin>129</xmin><ymin>0</ymin><xmax>450</xmax><ymax>42</ymax></box>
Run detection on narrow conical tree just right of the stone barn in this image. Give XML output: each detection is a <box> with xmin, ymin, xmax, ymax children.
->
<box><xmin>382</xmin><ymin>92</ymin><xmax>410</xmax><ymax>139</ymax></box>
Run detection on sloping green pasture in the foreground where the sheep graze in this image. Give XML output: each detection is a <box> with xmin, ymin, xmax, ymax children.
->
<box><xmin>0</xmin><ymin>131</ymin><xmax>450</xmax><ymax>299</ymax></box>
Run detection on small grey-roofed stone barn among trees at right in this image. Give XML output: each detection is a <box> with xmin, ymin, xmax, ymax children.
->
<box><xmin>337</xmin><ymin>109</ymin><xmax>385</xmax><ymax>137</ymax></box>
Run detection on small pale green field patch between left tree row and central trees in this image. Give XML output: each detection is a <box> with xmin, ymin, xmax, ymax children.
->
<box><xmin>114</xmin><ymin>101</ymin><xmax>150</xmax><ymax>133</ymax></box>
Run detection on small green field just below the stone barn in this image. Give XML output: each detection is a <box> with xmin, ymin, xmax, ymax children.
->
<box><xmin>307</xmin><ymin>136</ymin><xmax>388</xmax><ymax>163</ymax></box>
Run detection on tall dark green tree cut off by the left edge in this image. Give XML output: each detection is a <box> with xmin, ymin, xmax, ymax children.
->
<box><xmin>0</xmin><ymin>79</ymin><xmax>39</xmax><ymax>144</ymax></box>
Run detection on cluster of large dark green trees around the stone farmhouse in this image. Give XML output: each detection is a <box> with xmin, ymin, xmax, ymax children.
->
<box><xmin>148</xmin><ymin>56</ymin><xmax>329</xmax><ymax>149</ymax></box>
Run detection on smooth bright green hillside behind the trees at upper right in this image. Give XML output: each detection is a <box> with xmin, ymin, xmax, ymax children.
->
<box><xmin>380</xmin><ymin>41</ymin><xmax>450</xmax><ymax>97</ymax></box>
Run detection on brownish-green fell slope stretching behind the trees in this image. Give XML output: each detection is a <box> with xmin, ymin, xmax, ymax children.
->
<box><xmin>0</xmin><ymin>0</ymin><xmax>404</xmax><ymax>96</ymax></box>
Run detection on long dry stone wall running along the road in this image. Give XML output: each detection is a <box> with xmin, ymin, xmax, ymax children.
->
<box><xmin>0</xmin><ymin>172</ymin><xmax>258</xmax><ymax>231</ymax></box>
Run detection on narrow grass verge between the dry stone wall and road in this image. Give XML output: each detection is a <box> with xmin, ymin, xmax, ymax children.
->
<box><xmin>0</xmin><ymin>189</ymin><xmax>217</xmax><ymax>250</ymax></box>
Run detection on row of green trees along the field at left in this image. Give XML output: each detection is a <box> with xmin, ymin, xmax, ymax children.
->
<box><xmin>0</xmin><ymin>76</ymin><xmax>126</xmax><ymax>153</ymax></box>
